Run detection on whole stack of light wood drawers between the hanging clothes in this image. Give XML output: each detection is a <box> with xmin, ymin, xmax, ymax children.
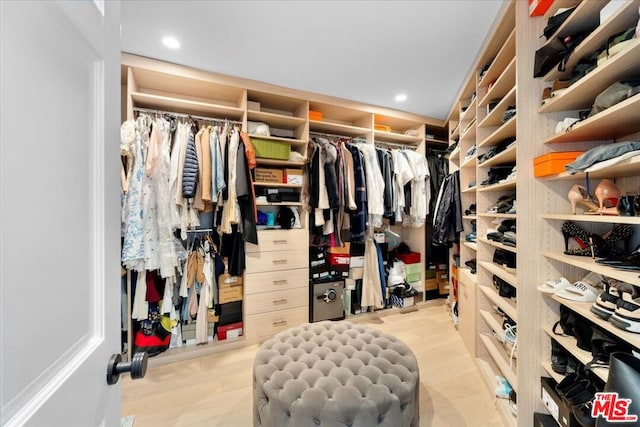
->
<box><xmin>244</xmin><ymin>229</ymin><xmax>309</xmax><ymax>339</ymax></box>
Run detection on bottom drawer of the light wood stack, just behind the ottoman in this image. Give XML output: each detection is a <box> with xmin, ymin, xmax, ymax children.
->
<box><xmin>244</xmin><ymin>306</ymin><xmax>309</xmax><ymax>339</ymax></box>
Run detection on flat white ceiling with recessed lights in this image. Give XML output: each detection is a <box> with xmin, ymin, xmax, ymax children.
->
<box><xmin>122</xmin><ymin>0</ymin><xmax>503</xmax><ymax>119</ymax></box>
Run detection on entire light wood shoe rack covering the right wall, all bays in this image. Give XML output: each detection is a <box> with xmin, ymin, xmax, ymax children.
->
<box><xmin>449</xmin><ymin>0</ymin><xmax>640</xmax><ymax>426</ymax></box>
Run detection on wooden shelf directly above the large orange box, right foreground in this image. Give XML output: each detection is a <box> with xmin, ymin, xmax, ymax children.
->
<box><xmin>544</xmin><ymin>94</ymin><xmax>640</xmax><ymax>144</ymax></box>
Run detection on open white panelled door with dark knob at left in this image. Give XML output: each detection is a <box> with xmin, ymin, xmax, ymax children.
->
<box><xmin>0</xmin><ymin>0</ymin><xmax>120</xmax><ymax>427</ymax></box>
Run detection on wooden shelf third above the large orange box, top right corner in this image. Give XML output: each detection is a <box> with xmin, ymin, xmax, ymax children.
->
<box><xmin>544</xmin><ymin>0</ymin><xmax>638</xmax><ymax>81</ymax></box>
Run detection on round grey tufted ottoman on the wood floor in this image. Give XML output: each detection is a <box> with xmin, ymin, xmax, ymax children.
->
<box><xmin>253</xmin><ymin>321</ymin><xmax>420</xmax><ymax>427</ymax></box>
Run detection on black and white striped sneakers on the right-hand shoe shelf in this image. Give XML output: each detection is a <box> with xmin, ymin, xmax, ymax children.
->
<box><xmin>591</xmin><ymin>279</ymin><xmax>640</xmax><ymax>333</ymax></box>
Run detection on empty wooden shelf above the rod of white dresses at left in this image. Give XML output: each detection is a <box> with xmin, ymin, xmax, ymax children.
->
<box><xmin>131</xmin><ymin>92</ymin><xmax>244</xmax><ymax>120</ymax></box>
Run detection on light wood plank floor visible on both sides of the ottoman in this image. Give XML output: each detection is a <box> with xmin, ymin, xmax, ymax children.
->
<box><xmin>122</xmin><ymin>300</ymin><xmax>503</xmax><ymax>427</ymax></box>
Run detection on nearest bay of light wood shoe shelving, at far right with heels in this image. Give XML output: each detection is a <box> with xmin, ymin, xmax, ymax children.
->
<box><xmin>526</xmin><ymin>0</ymin><xmax>640</xmax><ymax>426</ymax></box>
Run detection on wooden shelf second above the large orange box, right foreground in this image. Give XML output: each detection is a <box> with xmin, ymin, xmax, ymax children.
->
<box><xmin>539</xmin><ymin>40</ymin><xmax>640</xmax><ymax>113</ymax></box>
